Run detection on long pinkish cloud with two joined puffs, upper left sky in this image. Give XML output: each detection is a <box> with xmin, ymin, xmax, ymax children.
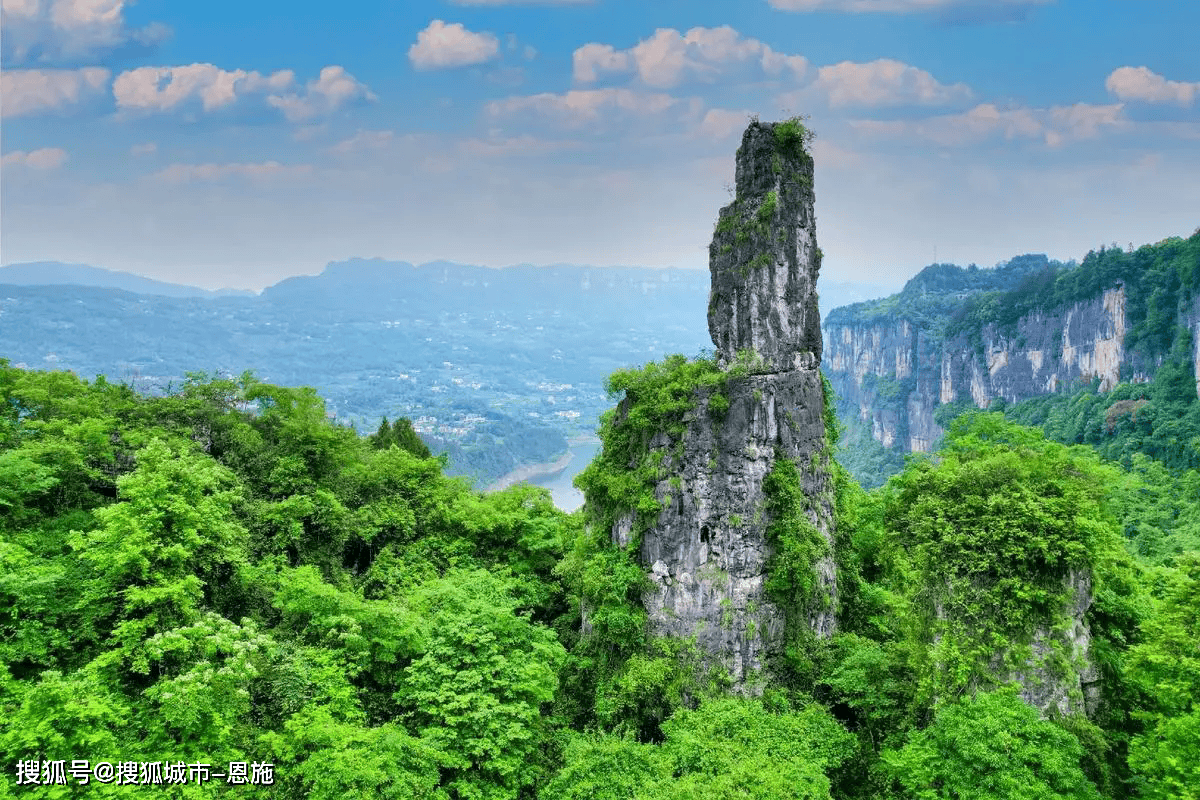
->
<box><xmin>113</xmin><ymin>64</ymin><xmax>374</xmax><ymax>122</ymax></box>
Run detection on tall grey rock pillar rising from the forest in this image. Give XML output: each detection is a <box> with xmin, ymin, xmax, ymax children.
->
<box><xmin>628</xmin><ymin>121</ymin><xmax>836</xmax><ymax>692</ymax></box>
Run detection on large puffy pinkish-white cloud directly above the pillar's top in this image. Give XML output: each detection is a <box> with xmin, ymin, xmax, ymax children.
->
<box><xmin>572</xmin><ymin>25</ymin><xmax>808</xmax><ymax>89</ymax></box>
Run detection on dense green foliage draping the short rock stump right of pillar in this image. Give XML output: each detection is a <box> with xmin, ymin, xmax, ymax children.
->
<box><xmin>884</xmin><ymin>414</ymin><xmax>1122</xmax><ymax>697</ymax></box>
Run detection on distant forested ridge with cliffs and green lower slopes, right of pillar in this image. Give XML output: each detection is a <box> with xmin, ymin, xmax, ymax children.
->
<box><xmin>826</xmin><ymin>229</ymin><xmax>1200</xmax><ymax>486</ymax></box>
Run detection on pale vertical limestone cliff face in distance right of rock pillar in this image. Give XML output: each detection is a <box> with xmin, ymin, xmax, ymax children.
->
<box><xmin>823</xmin><ymin>235</ymin><xmax>1200</xmax><ymax>472</ymax></box>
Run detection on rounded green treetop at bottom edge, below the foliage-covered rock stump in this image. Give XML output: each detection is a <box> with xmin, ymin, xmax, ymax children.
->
<box><xmin>883</xmin><ymin>688</ymin><xmax>1099</xmax><ymax>800</ymax></box>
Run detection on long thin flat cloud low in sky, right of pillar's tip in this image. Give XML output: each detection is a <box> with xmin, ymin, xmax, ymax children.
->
<box><xmin>851</xmin><ymin>103</ymin><xmax>1127</xmax><ymax>146</ymax></box>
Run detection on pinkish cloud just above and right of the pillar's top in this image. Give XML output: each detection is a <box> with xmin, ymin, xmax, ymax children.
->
<box><xmin>814</xmin><ymin>59</ymin><xmax>971</xmax><ymax>108</ymax></box>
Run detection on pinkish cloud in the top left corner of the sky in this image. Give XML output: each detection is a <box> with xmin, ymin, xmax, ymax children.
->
<box><xmin>0</xmin><ymin>0</ymin><xmax>170</xmax><ymax>64</ymax></box>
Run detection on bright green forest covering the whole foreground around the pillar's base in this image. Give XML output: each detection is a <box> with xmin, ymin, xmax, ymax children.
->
<box><xmin>0</xmin><ymin>357</ymin><xmax>1200</xmax><ymax>800</ymax></box>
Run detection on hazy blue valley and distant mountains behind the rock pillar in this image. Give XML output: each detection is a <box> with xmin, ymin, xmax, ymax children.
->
<box><xmin>0</xmin><ymin>259</ymin><xmax>902</xmax><ymax>483</ymax></box>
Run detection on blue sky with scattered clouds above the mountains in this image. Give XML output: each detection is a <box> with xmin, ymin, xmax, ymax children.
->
<box><xmin>0</xmin><ymin>0</ymin><xmax>1200</xmax><ymax>289</ymax></box>
